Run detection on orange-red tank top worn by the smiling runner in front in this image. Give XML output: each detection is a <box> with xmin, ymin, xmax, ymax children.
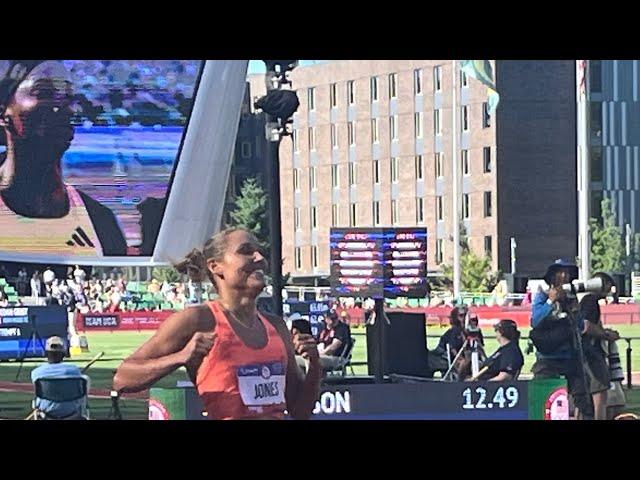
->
<box><xmin>196</xmin><ymin>301</ymin><xmax>287</xmax><ymax>420</ymax></box>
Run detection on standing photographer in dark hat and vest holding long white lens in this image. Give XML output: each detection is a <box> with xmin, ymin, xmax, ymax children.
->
<box><xmin>530</xmin><ymin>259</ymin><xmax>593</xmax><ymax>418</ymax></box>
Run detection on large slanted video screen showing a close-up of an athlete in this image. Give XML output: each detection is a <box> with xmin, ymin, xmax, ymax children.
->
<box><xmin>0</xmin><ymin>60</ymin><xmax>203</xmax><ymax>258</ymax></box>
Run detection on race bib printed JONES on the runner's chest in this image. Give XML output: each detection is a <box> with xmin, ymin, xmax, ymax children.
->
<box><xmin>237</xmin><ymin>362</ymin><xmax>286</xmax><ymax>407</ymax></box>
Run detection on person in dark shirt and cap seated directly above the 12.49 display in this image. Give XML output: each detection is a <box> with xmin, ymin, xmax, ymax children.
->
<box><xmin>478</xmin><ymin>319</ymin><xmax>524</xmax><ymax>382</ymax></box>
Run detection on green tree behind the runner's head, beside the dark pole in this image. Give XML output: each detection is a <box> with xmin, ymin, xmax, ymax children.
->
<box><xmin>229</xmin><ymin>177</ymin><xmax>270</xmax><ymax>250</ymax></box>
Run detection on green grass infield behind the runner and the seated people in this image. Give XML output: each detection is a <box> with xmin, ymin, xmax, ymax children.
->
<box><xmin>0</xmin><ymin>325</ymin><xmax>640</xmax><ymax>420</ymax></box>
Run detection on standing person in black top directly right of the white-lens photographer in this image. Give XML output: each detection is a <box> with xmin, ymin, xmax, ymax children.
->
<box><xmin>580</xmin><ymin>273</ymin><xmax>620</xmax><ymax>420</ymax></box>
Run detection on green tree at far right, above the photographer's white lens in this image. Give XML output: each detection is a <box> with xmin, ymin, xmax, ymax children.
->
<box><xmin>589</xmin><ymin>198</ymin><xmax>627</xmax><ymax>274</ymax></box>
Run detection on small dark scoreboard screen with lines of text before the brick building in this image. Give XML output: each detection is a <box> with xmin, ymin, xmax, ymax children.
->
<box><xmin>330</xmin><ymin>228</ymin><xmax>427</xmax><ymax>298</ymax></box>
